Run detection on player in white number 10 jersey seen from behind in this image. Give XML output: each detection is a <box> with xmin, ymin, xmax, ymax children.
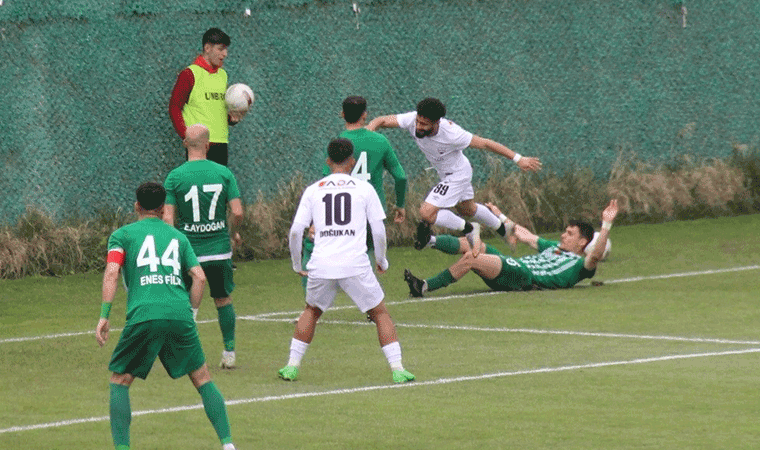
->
<box><xmin>279</xmin><ymin>138</ymin><xmax>415</xmax><ymax>383</ymax></box>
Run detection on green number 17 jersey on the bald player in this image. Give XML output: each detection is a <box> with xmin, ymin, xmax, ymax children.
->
<box><xmin>164</xmin><ymin>159</ymin><xmax>240</xmax><ymax>262</ymax></box>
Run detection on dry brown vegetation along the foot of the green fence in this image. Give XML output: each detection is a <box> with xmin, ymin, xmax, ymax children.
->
<box><xmin>0</xmin><ymin>150</ymin><xmax>760</xmax><ymax>278</ymax></box>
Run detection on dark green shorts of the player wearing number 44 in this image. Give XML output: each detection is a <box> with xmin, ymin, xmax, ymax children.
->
<box><xmin>108</xmin><ymin>320</ymin><xmax>206</xmax><ymax>380</ymax></box>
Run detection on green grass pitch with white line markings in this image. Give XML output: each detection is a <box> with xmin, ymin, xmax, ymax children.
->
<box><xmin>0</xmin><ymin>215</ymin><xmax>760</xmax><ymax>450</ymax></box>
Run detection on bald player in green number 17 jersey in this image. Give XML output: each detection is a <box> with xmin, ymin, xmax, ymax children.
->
<box><xmin>164</xmin><ymin>124</ymin><xmax>243</xmax><ymax>369</ymax></box>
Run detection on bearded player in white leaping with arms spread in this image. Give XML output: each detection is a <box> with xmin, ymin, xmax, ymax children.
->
<box><xmin>367</xmin><ymin>98</ymin><xmax>541</xmax><ymax>256</ymax></box>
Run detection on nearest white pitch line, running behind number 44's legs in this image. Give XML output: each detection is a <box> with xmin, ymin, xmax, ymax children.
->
<box><xmin>0</xmin><ymin>348</ymin><xmax>760</xmax><ymax>434</ymax></box>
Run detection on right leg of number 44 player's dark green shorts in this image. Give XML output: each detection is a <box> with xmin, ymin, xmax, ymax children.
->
<box><xmin>158</xmin><ymin>320</ymin><xmax>206</xmax><ymax>379</ymax></box>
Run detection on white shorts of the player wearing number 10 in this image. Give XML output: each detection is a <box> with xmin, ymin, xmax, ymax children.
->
<box><xmin>306</xmin><ymin>267</ymin><xmax>385</xmax><ymax>313</ymax></box>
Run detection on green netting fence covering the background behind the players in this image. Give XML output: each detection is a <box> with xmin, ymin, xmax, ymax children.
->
<box><xmin>0</xmin><ymin>0</ymin><xmax>760</xmax><ymax>222</ymax></box>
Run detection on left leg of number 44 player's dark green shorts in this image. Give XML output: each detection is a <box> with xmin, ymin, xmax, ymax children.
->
<box><xmin>108</xmin><ymin>320</ymin><xmax>163</xmax><ymax>380</ymax></box>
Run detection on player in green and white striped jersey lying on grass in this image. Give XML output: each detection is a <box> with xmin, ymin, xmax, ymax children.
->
<box><xmin>404</xmin><ymin>200</ymin><xmax>618</xmax><ymax>297</ymax></box>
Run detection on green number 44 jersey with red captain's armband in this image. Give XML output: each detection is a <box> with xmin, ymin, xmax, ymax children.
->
<box><xmin>108</xmin><ymin>218</ymin><xmax>198</xmax><ymax>324</ymax></box>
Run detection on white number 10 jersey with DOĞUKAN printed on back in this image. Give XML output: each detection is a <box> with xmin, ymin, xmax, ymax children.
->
<box><xmin>293</xmin><ymin>173</ymin><xmax>385</xmax><ymax>279</ymax></box>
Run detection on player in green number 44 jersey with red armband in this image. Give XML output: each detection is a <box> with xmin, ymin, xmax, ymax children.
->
<box><xmin>95</xmin><ymin>183</ymin><xmax>235</xmax><ymax>450</ymax></box>
